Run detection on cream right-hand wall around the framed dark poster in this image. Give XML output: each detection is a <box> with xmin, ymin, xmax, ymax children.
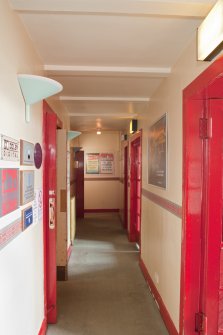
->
<box><xmin>139</xmin><ymin>36</ymin><xmax>215</xmax><ymax>330</ymax></box>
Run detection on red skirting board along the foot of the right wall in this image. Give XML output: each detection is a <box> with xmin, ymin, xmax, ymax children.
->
<box><xmin>139</xmin><ymin>258</ymin><xmax>179</xmax><ymax>335</ymax></box>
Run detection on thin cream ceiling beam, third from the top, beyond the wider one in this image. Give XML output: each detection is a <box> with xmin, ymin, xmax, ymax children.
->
<box><xmin>59</xmin><ymin>95</ymin><xmax>150</xmax><ymax>102</ymax></box>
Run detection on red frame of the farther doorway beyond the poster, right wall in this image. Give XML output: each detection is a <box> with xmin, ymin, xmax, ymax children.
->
<box><xmin>128</xmin><ymin>130</ymin><xmax>142</xmax><ymax>245</ymax></box>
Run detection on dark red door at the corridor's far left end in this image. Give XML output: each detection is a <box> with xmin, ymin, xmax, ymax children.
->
<box><xmin>74</xmin><ymin>151</ymin><xmax>84</xmax><ymax>218</ymax></box>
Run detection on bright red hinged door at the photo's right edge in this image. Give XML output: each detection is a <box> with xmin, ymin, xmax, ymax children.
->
<box><xmin>198</xmin><ymin>99</ymin><xmax>223</xmax><ymax>335</ymax></box>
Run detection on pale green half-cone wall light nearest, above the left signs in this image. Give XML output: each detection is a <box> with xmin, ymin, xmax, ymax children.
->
<box><xmin>18</xmin><ymin>74</ymin><xmax>63</xmax><ymax>122</ymax></box>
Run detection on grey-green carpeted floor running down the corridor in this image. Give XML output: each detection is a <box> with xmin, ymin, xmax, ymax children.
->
<box><xmin>47</xmin><ymin>214</ymin><xmax>168</xmax><ymax>335</ymax></box>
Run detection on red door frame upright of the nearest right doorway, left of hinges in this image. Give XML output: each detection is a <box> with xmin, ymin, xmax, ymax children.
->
<box><xmin>181</xmin><ymin>100</ymin><xmax>204</xmax><ymax>335</ymax></box>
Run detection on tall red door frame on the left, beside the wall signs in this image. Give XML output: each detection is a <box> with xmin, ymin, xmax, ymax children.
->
<box><xmin>43</xmin><ymin>101</ymin><xmax>62</xmax><ymax>324</ymax></box>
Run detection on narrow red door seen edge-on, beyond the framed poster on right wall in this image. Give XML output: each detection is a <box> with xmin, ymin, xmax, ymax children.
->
<box><xmin>129</xmin><ymin>137</ymin><xmax>142</xmax><ymax>244</ymax></box>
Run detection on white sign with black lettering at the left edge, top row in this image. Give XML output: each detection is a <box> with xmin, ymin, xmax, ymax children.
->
<box><xmin>0</xmin><ymin>135</ymin><xmax>19</xmax><ymax>161</ymax></box>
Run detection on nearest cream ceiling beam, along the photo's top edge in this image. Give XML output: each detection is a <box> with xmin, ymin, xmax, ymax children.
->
<box><xmin>10</xmin><ymin>0</ymin><xmax>214</xmax><ymax>18</ymax></box>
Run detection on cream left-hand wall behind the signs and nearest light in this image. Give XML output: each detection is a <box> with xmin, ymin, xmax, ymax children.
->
<box><xmin>0</xmin><ymin>0</ymin><xmax>44</xmax><ymax>335</ymax></box>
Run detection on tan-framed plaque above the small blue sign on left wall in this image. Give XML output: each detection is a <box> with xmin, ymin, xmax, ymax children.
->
<box><xmin>20</xmin><ymin>171</ymin><xmax>34</xmax><ymax>205</ymax></box>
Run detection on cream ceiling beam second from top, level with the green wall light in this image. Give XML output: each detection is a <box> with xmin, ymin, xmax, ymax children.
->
<box><xmin>44</xmin><ymin>65</ymin><xmax>171</xmax><ymax>78</ymax></box>
